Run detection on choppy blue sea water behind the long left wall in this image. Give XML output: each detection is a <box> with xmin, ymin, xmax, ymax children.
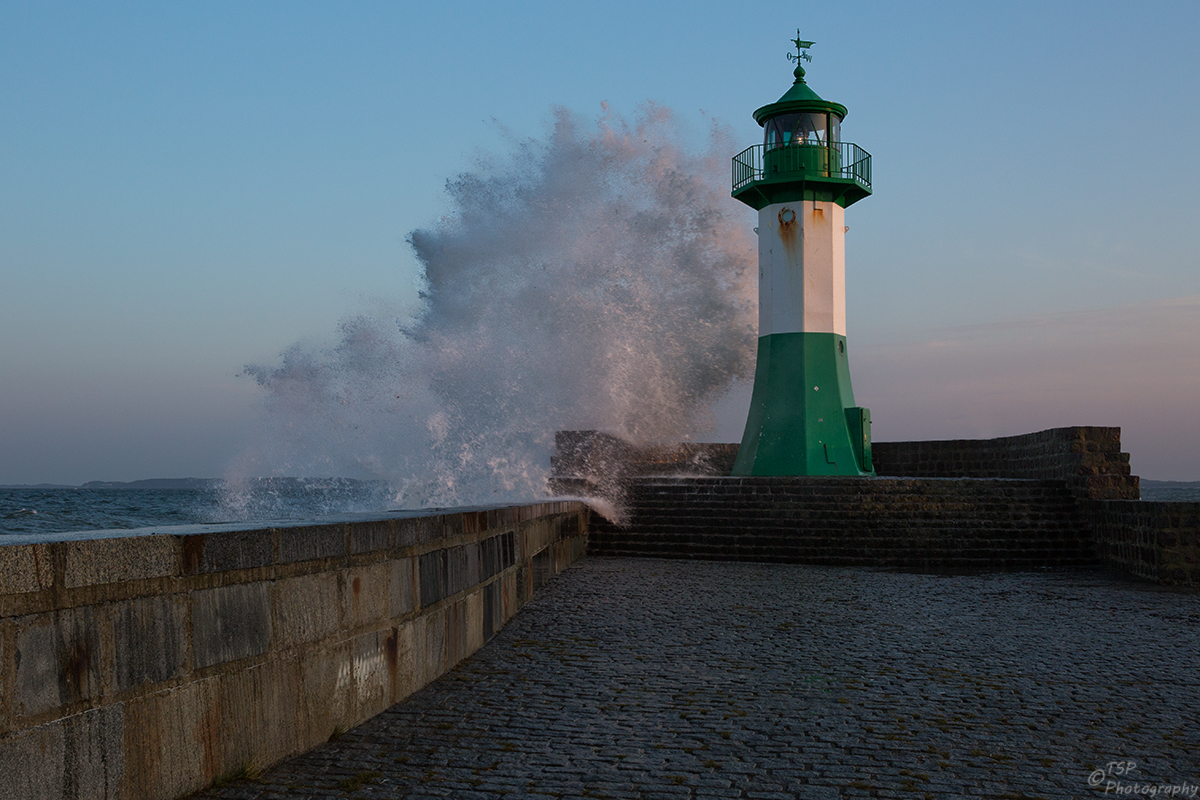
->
<box><xmin>0</xmin><ymin>479</ymin><xmax>395</xmax><ymax>537</ymax></box>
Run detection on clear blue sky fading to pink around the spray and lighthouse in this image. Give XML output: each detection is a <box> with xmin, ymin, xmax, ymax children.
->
<box><xmin>0</xmin><ymin>0</ymin><xmax>1200</xmax><ymax>483</ymax></box>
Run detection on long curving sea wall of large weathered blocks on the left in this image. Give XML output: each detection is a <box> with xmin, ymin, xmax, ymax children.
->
<box><xmin>0</xmin><ymin>501</ymin><xmax>587</xmax><ymax>800</ymax></box>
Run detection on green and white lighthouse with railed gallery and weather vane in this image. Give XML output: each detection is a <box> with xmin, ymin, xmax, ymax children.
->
<box><xmin>733</xmin><ymin>31</ymin><xmax>875</xmax><ymax>475</ymax></box>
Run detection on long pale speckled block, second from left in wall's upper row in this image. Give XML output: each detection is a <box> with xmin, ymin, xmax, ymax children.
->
<box><xmin>62</xmin><ymin>536</ymin><xmax>179</xmax><ymax>588</ymax></box>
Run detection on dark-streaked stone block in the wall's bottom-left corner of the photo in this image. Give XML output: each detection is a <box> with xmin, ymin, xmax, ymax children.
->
<box><xmin>0</xmin><ymin>705</ymin><xmax>125</xmax><ymax>800</ymax></box>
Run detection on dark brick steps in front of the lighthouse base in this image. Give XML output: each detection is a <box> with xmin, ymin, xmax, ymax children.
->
<box><xmin>588</xmin><ymin>476</ymin><xmax>1097</xmax><ymax>572</ymax></box>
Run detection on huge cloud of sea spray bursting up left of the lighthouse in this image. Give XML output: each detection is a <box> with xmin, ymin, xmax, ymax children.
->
<box><xmin>229</xmin><ymin>104</ymin><xmax>756</xmax><ymax>506</ymax></box>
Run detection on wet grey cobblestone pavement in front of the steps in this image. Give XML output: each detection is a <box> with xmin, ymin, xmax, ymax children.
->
<box><xmin>202</xmin><ymin>558</ymin><xmax>1200</xmax><ymax>800</ymax></box>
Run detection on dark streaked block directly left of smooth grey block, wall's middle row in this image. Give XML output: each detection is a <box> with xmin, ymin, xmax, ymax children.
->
<box><xmin>109</xmin><ymin>595</ymin><xmax>187</xmax><ymax>692</ymax></box>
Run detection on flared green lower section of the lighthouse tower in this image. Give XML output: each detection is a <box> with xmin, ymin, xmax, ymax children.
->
<box><xmin>733</xmin><ymin>333</ymin><xmax>875</xmax><ymax>475</ymax></box>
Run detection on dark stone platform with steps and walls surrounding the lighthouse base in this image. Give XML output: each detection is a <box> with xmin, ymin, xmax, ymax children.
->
<box><xmin>552</xmin><ymin>426</ymin><xmax>1200</xmax><ymax>588</ymax></box>
